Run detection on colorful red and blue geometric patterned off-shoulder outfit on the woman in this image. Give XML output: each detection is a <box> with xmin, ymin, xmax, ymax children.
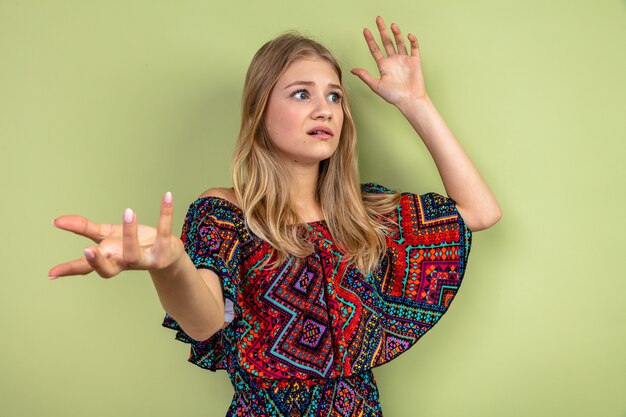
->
<box><xmin>163</xmin><ymin>183</ymin><xmax>472</xmax><ymax>417</ymax></box>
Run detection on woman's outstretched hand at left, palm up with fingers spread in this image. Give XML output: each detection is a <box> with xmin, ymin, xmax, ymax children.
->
<box><xmin>48</xmin><ymin>192</ymin><xmax>185</xmax><ymax>279</ymax></box>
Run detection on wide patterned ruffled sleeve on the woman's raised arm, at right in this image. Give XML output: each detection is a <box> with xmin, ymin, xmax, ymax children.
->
<box><xmin>357</xmin><ymin>184</ymin><xmax>472</xmax><ymax>367</ymax></box>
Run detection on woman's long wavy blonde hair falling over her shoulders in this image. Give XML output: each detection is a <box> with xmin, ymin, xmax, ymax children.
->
<box><xmin>232</xmin><ymin>33</ymin><xmax>399</xmax><ymax>276</ymax></box>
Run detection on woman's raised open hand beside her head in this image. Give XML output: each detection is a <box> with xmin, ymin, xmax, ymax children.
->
<box><xmin>351</xmin><ymin>16</ymin><xmax>427</xmax><ymax>107</ymax></box>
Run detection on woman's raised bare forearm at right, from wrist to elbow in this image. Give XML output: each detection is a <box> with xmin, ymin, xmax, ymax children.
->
<box><xmin>398</xmin><ymin>96</ymin><xmax>502</xmax><ymax>231</ymax></box>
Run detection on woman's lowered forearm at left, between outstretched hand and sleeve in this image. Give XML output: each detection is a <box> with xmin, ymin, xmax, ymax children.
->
<box><xmin>150</xmin><ymin>254</ymin><xmax>224</xmax><ymax>341</ymax></box>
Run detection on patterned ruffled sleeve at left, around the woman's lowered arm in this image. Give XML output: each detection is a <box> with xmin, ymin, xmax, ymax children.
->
<box><xmin>163</xmin><ymin>197</ymin><xmax>243</xmax><ymax>371</ymax></box>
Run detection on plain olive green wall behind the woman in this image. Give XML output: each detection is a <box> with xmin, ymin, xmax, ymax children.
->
<box><xmin>0</xmin><ymin>0</ymin><xmax>626</xmax><ymax>417</ymax></box>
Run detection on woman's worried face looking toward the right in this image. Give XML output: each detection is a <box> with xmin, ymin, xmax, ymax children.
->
<box><xmin>265</xmin><ymin>57</ymin><xmax>343</xmax><ymax>165</ymax></box>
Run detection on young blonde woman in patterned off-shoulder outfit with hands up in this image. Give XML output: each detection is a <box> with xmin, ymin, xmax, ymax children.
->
<box><xmin>50</xmin><ymin>17</ymin><xmax>501</xmax><ymax>416</ymax></box>
